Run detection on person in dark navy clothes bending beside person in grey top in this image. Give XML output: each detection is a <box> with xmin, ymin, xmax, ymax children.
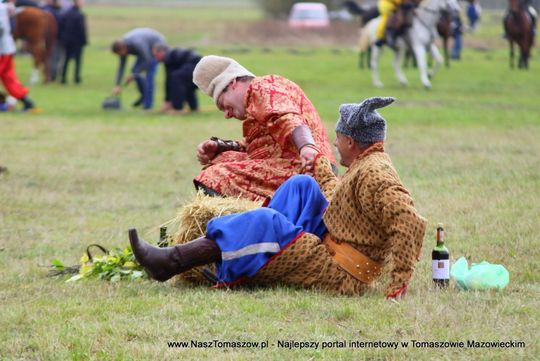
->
<box><xmin>152</xmin><ymin>44</ymin><xmax>201</xmax><ymax>112</ymax></box>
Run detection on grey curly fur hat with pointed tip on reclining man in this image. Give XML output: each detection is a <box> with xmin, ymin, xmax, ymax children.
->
<box><xmin>336</xmin><ymin>97</ymin><xmax>396</xmax><ymax>144</ymax></box>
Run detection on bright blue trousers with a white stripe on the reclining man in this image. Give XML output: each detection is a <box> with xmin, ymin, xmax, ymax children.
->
<box><xmin>206</xmin><ymin>175</ymin><xmax>328</xmax><ymax>284</ymax></box>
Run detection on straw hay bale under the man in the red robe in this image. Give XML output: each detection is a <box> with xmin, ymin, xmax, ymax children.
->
<box><xmin>170</xmin><ymin>192</ymin><xmax>261</xmax><ymax>286</ymax></box>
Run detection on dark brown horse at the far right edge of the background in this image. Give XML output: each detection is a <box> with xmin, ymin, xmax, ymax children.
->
<box><xmin>503</xmin><ymin>0</ymin><xmax>534</xmax><ymax>69</ymax></box>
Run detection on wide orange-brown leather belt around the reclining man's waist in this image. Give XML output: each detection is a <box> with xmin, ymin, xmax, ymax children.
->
<box><xmin>323</xmin><ymin>233</ymin><xmax>382</xmax><ymax>283</ymax></box>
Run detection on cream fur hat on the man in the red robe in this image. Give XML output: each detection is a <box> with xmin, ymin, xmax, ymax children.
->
<box><xmin>193</xmin><ymin>55</ymin><xmax>255</xmax><ymax>104</ymax></box>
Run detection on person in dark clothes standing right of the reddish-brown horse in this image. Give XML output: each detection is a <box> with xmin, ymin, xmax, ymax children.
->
<box><xmin>60</xmin><ymin>0</ymin><xmax>88</xmax><ymax>84</ymax></box>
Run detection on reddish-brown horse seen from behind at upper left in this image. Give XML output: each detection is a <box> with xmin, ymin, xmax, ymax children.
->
<box><xmin>13</xmin><ymin>7</ymin><xmax>58</xmax><ymax>84</ymax></box>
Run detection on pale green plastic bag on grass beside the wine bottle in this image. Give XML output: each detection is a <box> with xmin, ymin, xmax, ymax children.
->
<box><xmin>450</xmin><ymin>257</ymin><xmax>510</xmax><ymax>290</ymax></box>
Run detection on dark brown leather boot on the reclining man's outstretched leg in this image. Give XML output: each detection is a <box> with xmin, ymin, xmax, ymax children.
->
<box><xmin>129</xmin><ymin>229</ymin><xmax>221</xmax><ymax>282</ymax></box>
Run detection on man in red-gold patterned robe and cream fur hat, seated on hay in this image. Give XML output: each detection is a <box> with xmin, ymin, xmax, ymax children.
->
<box><xmin>193</xmin><ymin>55</ymin><xmax>335</xmax><ymax>200</ymax></box>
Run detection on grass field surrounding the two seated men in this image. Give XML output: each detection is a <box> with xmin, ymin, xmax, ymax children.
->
<box><xmin>0</xmin><ymin>5</ymin><xmax>540</xmax><ymax>360</ymax></box>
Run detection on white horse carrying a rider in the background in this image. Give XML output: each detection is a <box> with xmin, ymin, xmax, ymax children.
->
<box><xmin>359</xmin><ymin>0</ymin><xmax>459</xmax><ymax>89</ymax></box>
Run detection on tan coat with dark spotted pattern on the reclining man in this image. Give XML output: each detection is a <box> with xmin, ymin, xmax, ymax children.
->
<box><xmin>252</xmin><ymin>143</ymin><xmax>426</xmax><ymax>295</ymax></box>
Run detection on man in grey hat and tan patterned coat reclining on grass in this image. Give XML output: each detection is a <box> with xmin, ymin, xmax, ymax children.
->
<box><xmin>129</xmin><ymin>98</ymin><xmax>426</xmax><ymax>299</ymax></box>
